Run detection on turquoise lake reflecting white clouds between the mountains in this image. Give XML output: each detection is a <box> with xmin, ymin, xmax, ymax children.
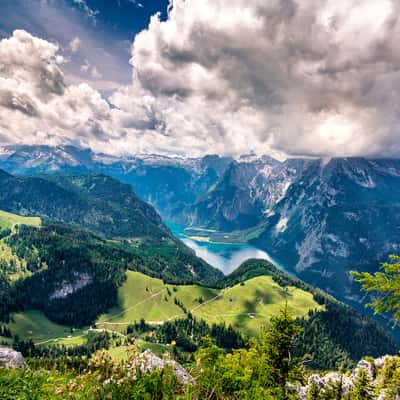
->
<box><xmin>167</xmin><ymin>222</ymin><xmax>286</xmax><ymax>274</ymax></box>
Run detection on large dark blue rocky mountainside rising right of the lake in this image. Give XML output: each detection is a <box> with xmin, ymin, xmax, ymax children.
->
<box><xmin>254</xmin><ymin>159</ymin><xmax>400</xmax><ymax>302</ymax></box>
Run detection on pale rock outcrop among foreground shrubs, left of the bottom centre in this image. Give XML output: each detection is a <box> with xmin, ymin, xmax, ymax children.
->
<box><xmin>133</xmin><ymin>350</ymin><xmax>194</xmax><ymax>385</ymax></box>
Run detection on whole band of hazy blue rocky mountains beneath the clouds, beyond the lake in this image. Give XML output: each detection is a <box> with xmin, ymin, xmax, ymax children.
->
<box><xmin>0</xmin><ymin>146</ymin><xmax>400</xmax><ymax>310</ymax></box>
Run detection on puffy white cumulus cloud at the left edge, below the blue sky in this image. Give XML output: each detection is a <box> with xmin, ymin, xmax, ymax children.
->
<box><xmin>0</xmin><ymin>30</ymin><xmax>116</xmax><ymax>150</ymax></box>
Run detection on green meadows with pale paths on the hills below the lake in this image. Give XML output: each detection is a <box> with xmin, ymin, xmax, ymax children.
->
<box><xmin>5</xmin><ymin>271</ymin><xmax>321</xmax><ymax>344</ymax></box>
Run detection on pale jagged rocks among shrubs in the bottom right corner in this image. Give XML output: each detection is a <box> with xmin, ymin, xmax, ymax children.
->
<box><xmin>293</xmin><ymin>356</ymin><xmax>400</xmax><ymax>400</ymax></box>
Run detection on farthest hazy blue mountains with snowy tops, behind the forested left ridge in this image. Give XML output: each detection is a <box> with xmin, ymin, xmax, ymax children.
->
<box><xmin>0</xmin><ymin>146</ymin><xmax>232</xmax><ymax>222</ymax></box>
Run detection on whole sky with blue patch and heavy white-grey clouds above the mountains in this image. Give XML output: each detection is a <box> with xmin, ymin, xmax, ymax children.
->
<box><xmin>0</xmin><ymin>0</ymin><xmax>400</xmax><ymax>158</ymax></box>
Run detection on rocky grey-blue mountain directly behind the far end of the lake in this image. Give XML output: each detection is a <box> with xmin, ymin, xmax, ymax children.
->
<box><xmin>183</xmin><ymin>157</ymin><xmax>307</xmax><ymax>232</ymax></box>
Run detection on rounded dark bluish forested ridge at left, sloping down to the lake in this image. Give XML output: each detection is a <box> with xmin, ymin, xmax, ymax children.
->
<box><xmin>0</xmin><ymin>170</ymin><xmax>171</xmax><ymax>239</ymax></box>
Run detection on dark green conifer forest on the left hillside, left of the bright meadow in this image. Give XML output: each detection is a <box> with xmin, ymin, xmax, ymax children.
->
<box><xmin>0</xmin><ymin>222</ymin><xmax>219</xmax><ymax>327</ymax></box>
